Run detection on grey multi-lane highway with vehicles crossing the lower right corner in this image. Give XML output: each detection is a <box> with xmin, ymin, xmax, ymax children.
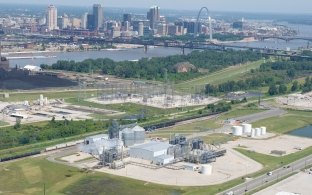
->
<box><xmin>220</xmin><ymin>155</ymin><xmax>312</xmax><ymax>195</ymax></box>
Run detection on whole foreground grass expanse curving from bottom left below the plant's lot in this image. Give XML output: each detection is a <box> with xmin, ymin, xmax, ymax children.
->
<box><xmin>0</xmin><ymin>157</ymin><xmax>242</xmax><ymax>195</ymax></box>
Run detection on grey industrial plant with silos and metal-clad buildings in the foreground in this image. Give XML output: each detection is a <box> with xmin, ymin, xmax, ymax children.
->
<box><xmin>80</xmin><ymin>121</ymin><xmax>226</xmax><ymax>174</ymax></box>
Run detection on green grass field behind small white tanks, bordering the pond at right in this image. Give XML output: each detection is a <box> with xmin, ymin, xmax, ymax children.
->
<box><xmin>253</xmin><ymin>111</ymin><xmax>312</xmax><ymax>134</ymax></box>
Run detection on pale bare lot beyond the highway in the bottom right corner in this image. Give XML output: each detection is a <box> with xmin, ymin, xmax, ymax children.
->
<box><xmin>255</xmin><ymin>172</ymin><xmax>312</xmax><ymax>195</ymax></box>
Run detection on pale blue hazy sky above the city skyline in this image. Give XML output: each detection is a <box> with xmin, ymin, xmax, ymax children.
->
<box><xmin>0</xmin><ymin>0</ymin><xmax>312</xmax><ymax>14</ymax></box>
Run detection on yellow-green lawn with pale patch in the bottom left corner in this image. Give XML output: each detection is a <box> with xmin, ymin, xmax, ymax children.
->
<box><xmin>0</xmin><ymin>158</ymin><xmax>85</xmax><ymax>195</ymax></box>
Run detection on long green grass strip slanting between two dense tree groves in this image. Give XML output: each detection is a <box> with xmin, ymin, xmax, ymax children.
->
<box><xmin>175</xmin><ymin>60</ymin><xmax>263</xmax><ymax>92</ymax></box>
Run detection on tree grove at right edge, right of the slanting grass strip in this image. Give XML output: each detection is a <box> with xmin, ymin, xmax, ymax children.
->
<box><xmin>205</xmin><ymin>60</ymin><xmax>312</xmax><ymax>95</ymax></box>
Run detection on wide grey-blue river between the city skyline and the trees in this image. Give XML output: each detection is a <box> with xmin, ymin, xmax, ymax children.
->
<box><xmin>10</xmin><ymin>23</ymin><xmax>312</xmax><ymax>67</ymax></box>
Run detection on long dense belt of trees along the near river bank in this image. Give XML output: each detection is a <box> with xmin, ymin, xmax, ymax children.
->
<box><xmin>41</xmin><ymin>50</ymin><xmax>261</xmax><ymax>81</ymax></box>
